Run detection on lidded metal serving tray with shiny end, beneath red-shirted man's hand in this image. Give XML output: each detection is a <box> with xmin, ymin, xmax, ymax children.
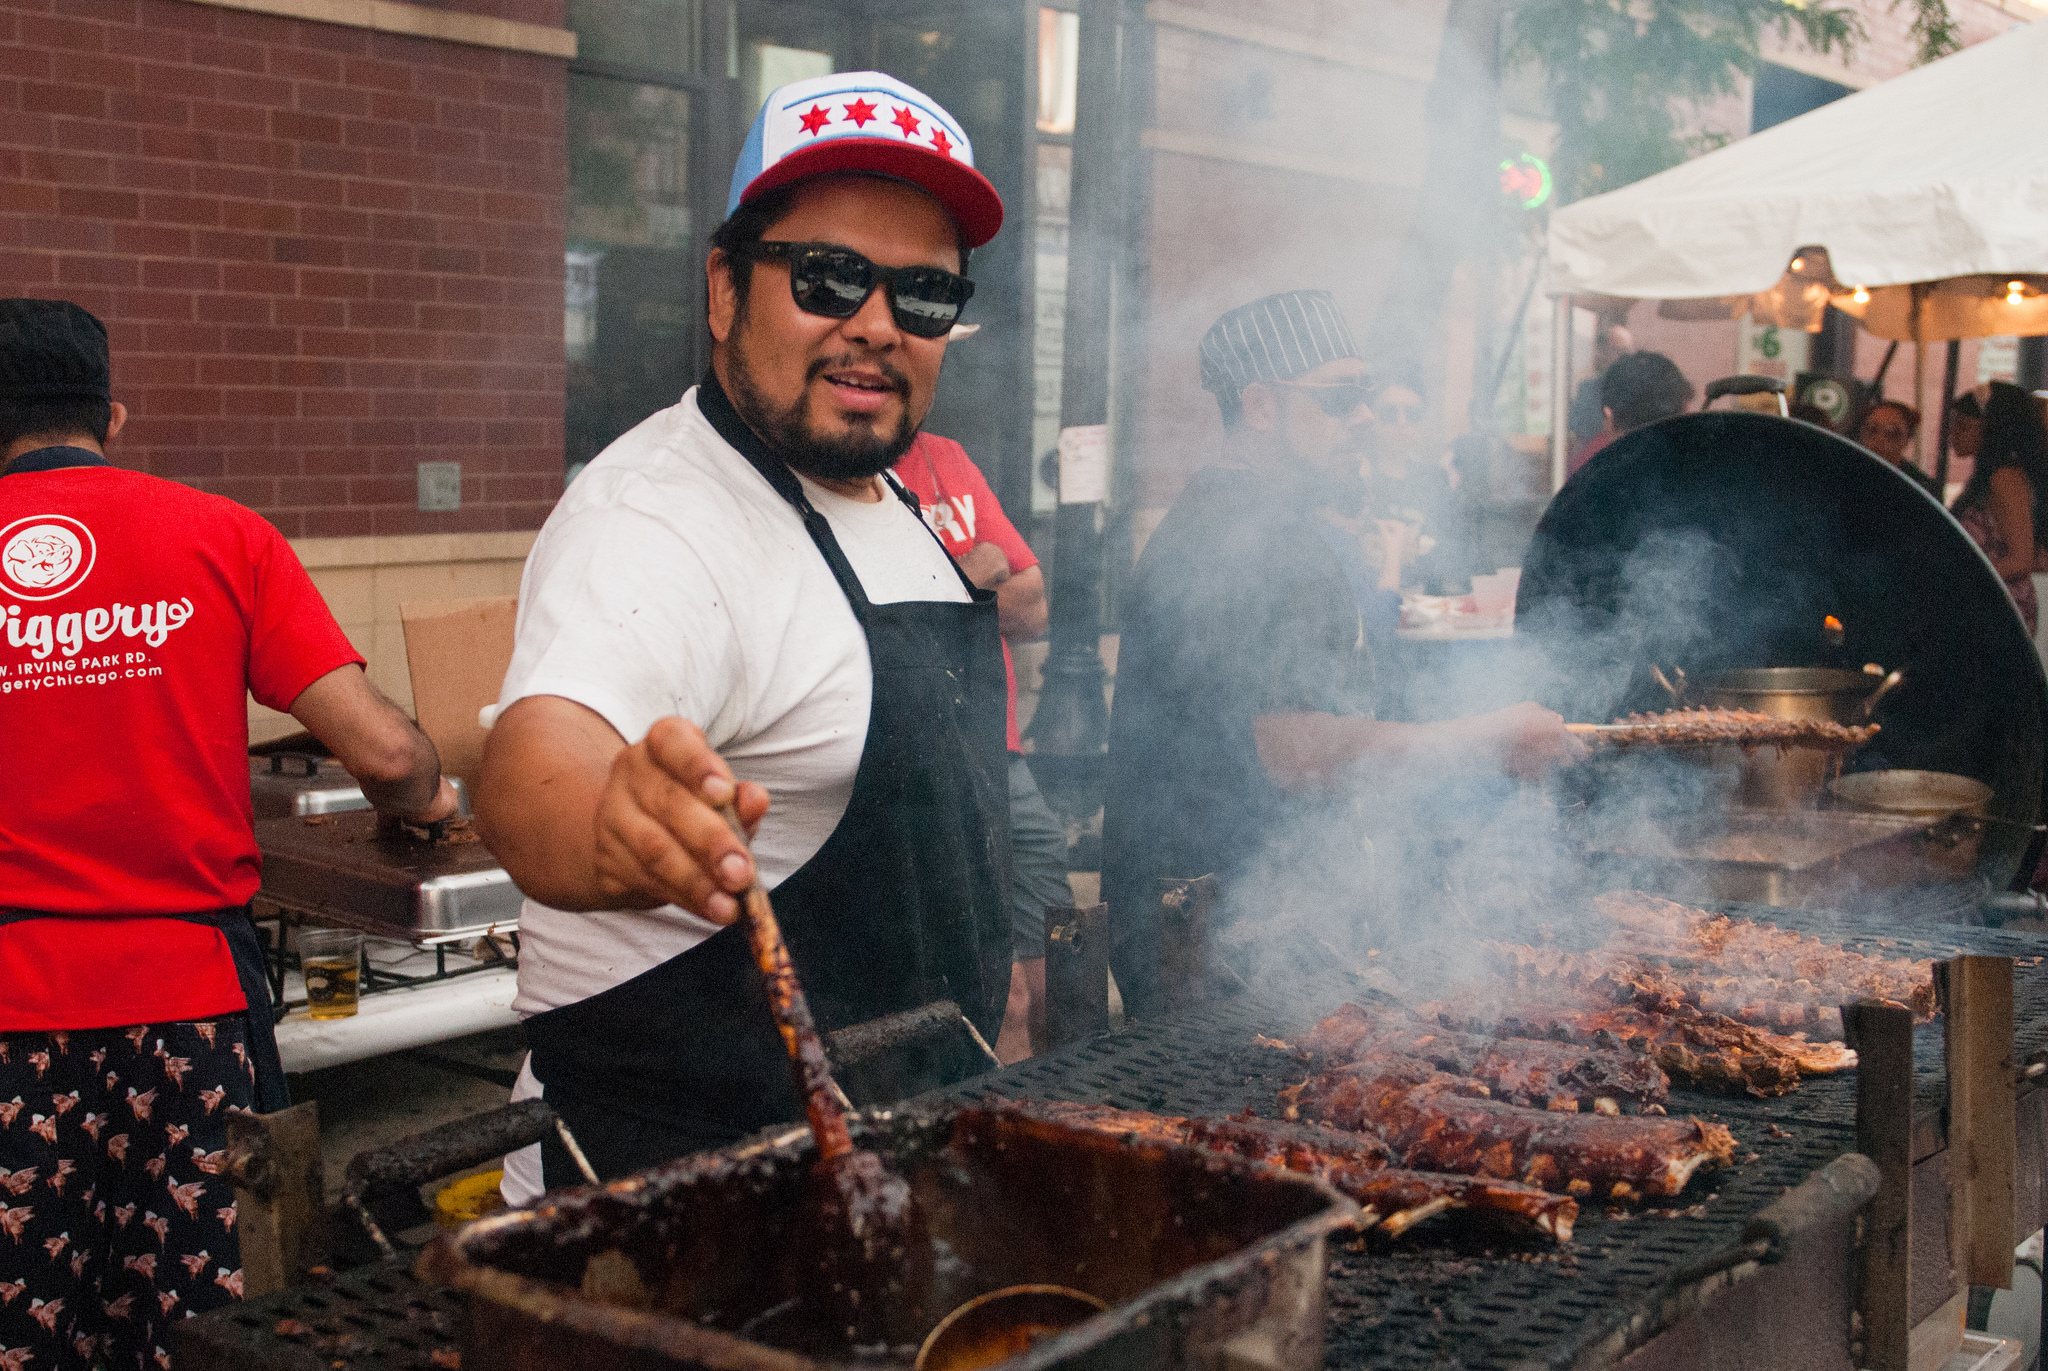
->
<box><xmin>256</xmin><ymin>809</ymin><xmax>522</xmax><ymax>943</ymax></box>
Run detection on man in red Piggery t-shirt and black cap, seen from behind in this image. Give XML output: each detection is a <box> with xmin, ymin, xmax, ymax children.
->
<box><xmin>0</xmin><ymin>299</ymin><xmax>457</xmax><ymax>1371</ymax></box>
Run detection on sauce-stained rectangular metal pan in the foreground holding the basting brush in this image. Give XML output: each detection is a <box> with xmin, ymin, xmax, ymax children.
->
<box><xmin>420</xmin><ymin>1103</ymin><xmax>1358</xmax><ymax>1371</ymax></box>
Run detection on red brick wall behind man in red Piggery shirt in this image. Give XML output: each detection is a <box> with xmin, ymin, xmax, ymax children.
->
<box><xmin>0</xmin><ymin>0</ymin><xmax>565</xmax><ymax>537</ymax></box>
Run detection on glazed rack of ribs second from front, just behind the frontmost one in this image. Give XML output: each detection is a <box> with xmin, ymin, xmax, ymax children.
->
<box><xmin>1280</xmin><ymin>1057</ymin><xmax>1735</xmax><ymax>1199</ymax></box>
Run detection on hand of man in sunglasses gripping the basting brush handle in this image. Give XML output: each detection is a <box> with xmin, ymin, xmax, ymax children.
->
<box><xmin>594</xmin><ymin>719</ymin><xmax>768</xmax><ymax>924</ymax></box>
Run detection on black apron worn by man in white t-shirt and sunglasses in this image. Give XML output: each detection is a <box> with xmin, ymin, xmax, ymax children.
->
<box><xmin>526</xmin><ymin>377</ymin><xmax>1010</xmax><ymax>1187</ymax></box>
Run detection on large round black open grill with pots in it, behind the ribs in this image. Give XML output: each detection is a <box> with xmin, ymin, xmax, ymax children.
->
<box><xmin>1516</xmin><ymin>412</ymin><xmax>2048</xmax><ymax>906</ymax></box>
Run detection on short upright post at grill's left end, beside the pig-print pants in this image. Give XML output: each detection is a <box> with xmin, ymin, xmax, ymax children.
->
<box><xmin>227</xmin><ymin>1100</ymin><xmax>326</xmax><ymax>1299</ymax></box>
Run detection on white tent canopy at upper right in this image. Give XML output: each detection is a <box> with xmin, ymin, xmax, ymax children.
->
<box><xmin>1546</xmin><ymin>23</ymin><xmax>2048</xmax><ymax>299</ymax></box>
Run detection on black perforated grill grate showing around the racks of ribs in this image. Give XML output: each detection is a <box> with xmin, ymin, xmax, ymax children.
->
<box><xmin>176</xmin><ymin>906</ymin><xmax>2048</xmax><ymax>1371</ymax></box>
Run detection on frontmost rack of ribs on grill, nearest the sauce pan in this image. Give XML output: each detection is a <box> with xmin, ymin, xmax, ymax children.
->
<box><xmin>1018</xmin><ymin>1100</ymin><xmax>1579</xmax><ymax>1242</ymax></box>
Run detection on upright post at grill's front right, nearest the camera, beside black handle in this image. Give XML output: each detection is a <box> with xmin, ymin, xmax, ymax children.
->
<box><xmin>1841</xmin><ymin>1000</ymin><xmax>1913</xmax><ymax>1371</ymax></box>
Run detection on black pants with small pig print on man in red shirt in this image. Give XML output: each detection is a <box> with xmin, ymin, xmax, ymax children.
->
<box><xmin>0</xmin><ymin>1014</ymin><xmax>256</xmax><ymax>1371</ymax></box>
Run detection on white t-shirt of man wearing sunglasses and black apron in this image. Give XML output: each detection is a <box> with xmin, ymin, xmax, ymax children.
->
<box><xmin>498</xmin><ymin>387</ymin><xmax>967</xmax><ymax>1014</ymax></box>
